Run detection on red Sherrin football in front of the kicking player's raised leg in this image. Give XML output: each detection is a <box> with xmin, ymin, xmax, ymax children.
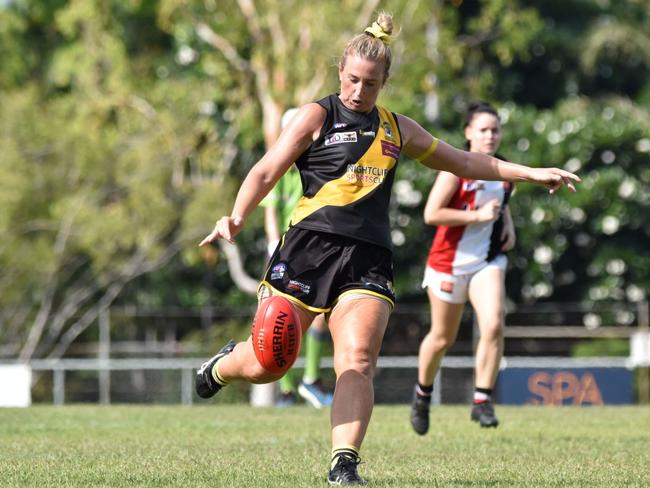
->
<box><xmin>251</xmin><ymin>296</ymin><xmax>302</xmax><ymax>374</ymax></box>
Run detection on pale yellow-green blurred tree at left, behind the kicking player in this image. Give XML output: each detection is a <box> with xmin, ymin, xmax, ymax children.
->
<box><xmin>0</xmin><ymin>2</ymin><xmax>239</xmax><ymax>360</ymax></box>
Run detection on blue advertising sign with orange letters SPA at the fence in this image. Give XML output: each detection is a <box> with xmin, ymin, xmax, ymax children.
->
<box><xmin>497</xmin><ymin>368</ymin><xmax>634</xmax><ymax>405</ymax></box>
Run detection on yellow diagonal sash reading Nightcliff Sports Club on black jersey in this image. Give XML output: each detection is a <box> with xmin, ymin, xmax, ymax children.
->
<box><xmin>291</xmin><ymin>107</ymin><xmax>402</xmax><ymax>225</ymax></box>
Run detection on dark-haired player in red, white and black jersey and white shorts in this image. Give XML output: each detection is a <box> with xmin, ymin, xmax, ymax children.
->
<box><xmin>411</xmin><ymin>102</ymin><xmax>515</xmax><ymax>435</ymax></box>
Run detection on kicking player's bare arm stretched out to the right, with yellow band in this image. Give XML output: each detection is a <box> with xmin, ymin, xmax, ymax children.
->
<box><xmin>398</xmin><ymin>115</ymin><xmax>580</xmax><ymax>193</ymax></box>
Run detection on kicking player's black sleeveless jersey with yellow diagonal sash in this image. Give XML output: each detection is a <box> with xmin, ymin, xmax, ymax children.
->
<box><xmin>291</xmin><ymin>94</ymin><xmax>402</xmax><ymax>249</ymax></box>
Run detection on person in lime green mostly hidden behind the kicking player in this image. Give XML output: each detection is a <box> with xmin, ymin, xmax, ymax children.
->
<box><xmin>260</xmin><ymin>108</ymin><xmax>333</xmax><ymax>408</ymax></box>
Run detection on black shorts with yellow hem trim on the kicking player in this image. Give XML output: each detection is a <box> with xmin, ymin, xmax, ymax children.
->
<box><xmin>260</xmin><ymin>227</ymin><xmax>395</xmax><ymax>313</ymax></box>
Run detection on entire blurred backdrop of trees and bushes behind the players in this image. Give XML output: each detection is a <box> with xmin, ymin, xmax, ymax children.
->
<box><xmin>0</xmin><ymin>0</ymin><xmax>650</xmax><ymax>358</ymax></box>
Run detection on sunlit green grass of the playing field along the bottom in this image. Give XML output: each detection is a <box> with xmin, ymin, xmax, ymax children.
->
<box><xmin>0</xmin><ymin>404</ymin><xmax>650</xmax><ymax>488</ymax></box>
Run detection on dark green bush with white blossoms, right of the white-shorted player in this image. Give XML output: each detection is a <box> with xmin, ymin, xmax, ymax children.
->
<box><xmin>498</xmin><ymin>99</ymin><xmax>650</xmax><ymax>308</ymax></box>
